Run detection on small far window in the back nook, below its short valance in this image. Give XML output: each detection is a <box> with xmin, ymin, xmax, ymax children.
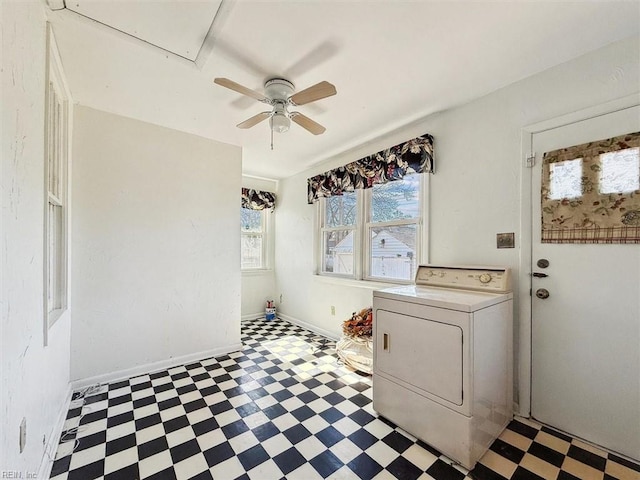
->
<box><xmin>240</xmin><ymin>208</ymin><xmax>270</xmax><ymax>270</ymax></box>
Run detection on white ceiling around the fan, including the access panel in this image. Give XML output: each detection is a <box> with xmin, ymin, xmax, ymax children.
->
<box><xmin>51</xmin><ymin>0</ymin><xmax>640</xmax><ymax>178</ymax></box>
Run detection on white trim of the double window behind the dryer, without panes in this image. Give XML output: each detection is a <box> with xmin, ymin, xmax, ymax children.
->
<box><xmin>313</xmin><ymin>174</ymin><xmax>430</xmax><ymax>288</ymax></box>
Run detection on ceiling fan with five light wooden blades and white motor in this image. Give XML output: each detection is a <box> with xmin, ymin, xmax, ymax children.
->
<box><xmin>214</xmin><ymin>78</ymin><xmax>337</xmax><ymax>145</ymax></box>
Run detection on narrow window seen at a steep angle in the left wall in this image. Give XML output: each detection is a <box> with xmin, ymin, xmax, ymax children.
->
<box><xmin>44</xmin><ymin>24</ymin><xmax>70</xmax><ymax>331</ymax></box>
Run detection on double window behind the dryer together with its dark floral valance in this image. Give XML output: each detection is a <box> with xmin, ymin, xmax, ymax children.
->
<box><xmin>308</xmin><ymin>135</ymin><xmax>433</xmax><ymax>283</ymax></box>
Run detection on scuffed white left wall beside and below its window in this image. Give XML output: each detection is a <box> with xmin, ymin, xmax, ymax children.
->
<box><xmin>0</xmin><ymin>1</ymin><xmax>70</xmax><ymax>478</ymax></box>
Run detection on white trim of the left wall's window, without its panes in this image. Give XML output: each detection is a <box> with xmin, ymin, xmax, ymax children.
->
<box><xmin>43</xmin><ymin>24</ymin><xmax>73</xmax><ymax>345</ymax></box>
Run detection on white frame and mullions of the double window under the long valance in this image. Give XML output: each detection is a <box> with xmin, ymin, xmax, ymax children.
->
<box><xmin>314</xmin><ymin>174</ymin><xmax>429</xmax><ymax>285</ymax></box>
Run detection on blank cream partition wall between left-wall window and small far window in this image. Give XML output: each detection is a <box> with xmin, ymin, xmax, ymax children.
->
<box><xmin>71</xmin><ymin>106</ymin><xmax>241</xmax><ymax>380</ymax></box>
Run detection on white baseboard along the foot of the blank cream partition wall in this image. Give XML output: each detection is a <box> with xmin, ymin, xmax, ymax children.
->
<box><xmin>71</xmin><ymin>343</ymin><xmax>242</xmax><ymax>392</ymax></box>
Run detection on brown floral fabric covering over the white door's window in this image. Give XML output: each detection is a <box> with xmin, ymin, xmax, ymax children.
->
<box><xmin>542</xmin><ymin>132</ymin><xmax>640</xmax><ymax>243</ymax></box>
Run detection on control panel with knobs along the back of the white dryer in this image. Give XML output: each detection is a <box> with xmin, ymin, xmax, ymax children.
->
<box><xmin>416</xmin><ymin>265</ymin><xmax>511</xmax><ymax>293</ymax></box>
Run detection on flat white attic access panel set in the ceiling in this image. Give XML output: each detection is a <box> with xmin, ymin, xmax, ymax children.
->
<box><xmin>65</xmin><ymin>0</ymin><xmax>222</xmax><ymax>61</ymax></box>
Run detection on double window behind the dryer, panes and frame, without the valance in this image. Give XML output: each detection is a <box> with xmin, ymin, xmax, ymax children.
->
<box><xmin>319</xmin><ymin>175</ymin><xmax>422</xmax><ymax>282</ymax></box>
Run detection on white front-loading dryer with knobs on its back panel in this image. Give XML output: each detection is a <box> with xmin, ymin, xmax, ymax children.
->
<box><xmin>373</xmin><ymin>265</ymin><xmax>513</xmax><ymax>469</ymax></box>
